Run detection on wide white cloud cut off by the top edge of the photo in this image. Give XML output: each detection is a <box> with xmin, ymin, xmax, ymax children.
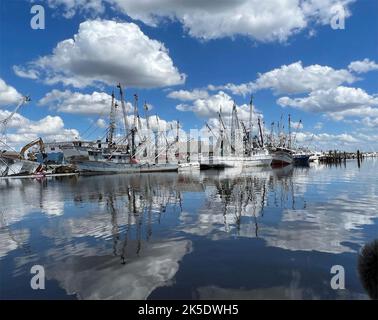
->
<box><xmin>43</xmin><ymin>0</ymin><xmax>353</xmax><ymax>42</ymax></box>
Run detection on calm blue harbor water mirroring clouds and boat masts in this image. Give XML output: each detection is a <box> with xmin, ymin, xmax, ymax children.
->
<box><xmin>0</xmin><ymin>159</ymin><xmax>378</xmax><ymax>299</ymax></box>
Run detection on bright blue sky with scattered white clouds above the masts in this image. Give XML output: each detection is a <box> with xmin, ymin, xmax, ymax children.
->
<box><xmin>0</xmin><ymin>0</ymin><xmax>378</xmax><ymax>150</ymax></box>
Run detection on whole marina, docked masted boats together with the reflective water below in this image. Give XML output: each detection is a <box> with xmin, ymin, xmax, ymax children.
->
<box><xmin>0</xmin><ymin>84</ymin><xmax>378</xmax><ymax>300</ymax></box>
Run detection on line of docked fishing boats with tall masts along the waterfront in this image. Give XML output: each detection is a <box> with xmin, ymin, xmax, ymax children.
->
<box><xmin>0</xmin><ymin>90</ymin><xmax>377</xmax><ymax>178</ymax></box>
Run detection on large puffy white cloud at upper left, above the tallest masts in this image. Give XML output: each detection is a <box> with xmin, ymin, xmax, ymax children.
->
<box><xmin>14</xmin><ymin>20</ymin><xmax>186</xmax><ymax>88</ymax></box>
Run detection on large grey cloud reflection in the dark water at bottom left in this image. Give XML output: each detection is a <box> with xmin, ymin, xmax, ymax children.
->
<box><xmin>46</xmin><ymin>239</ymin><xmax>191</xmax><ymax>299</ymax></box>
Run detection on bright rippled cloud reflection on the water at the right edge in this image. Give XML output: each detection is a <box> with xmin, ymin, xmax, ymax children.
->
<box><xmin>262</xmin><ymin>197</ymin><xmax>378</xmax><ymax>253</ymax></box>
